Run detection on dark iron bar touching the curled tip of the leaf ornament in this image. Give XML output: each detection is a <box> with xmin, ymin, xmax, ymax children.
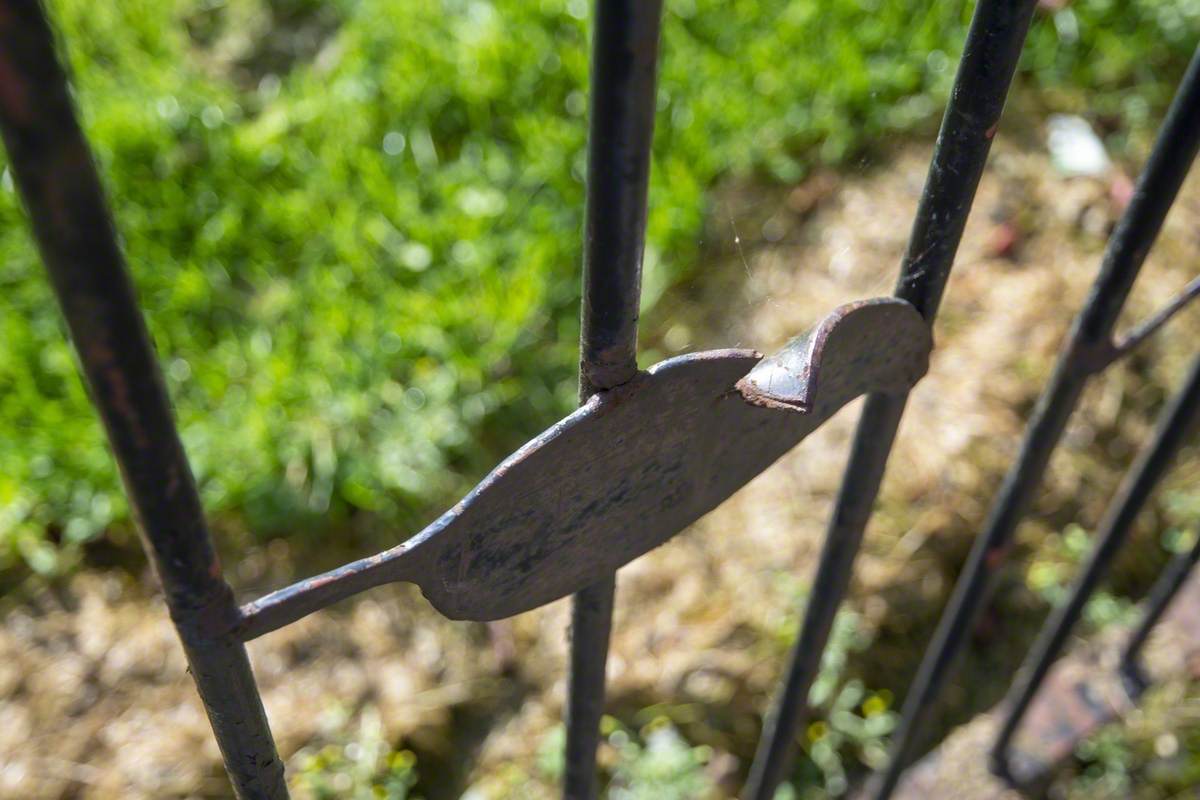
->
<box><xmin>743</xmin><ymin>0</ymin><xmax>1034</xmax><ymax>800</ymax></box>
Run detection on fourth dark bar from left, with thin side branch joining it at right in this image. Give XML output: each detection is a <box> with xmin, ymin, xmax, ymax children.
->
<box><xmin>872</xmin><ymin>42</ymin><xmax>1200</xmax><ymax>800</ymax></box>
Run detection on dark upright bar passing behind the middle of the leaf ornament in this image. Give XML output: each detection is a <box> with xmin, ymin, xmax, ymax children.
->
<box><xmin>563</xmin><ymin>0</ymin><xmax>662</xmax><ymax>800</ymax></box>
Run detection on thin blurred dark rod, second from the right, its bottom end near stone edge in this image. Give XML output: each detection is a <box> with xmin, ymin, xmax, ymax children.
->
<box><xmin>991</xmin><ymin>359</ymin><xmax>1200</xmax><ymax>776</ymax></box>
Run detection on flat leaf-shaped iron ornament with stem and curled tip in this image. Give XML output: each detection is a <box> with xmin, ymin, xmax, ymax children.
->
<box><xmin>239</xmin><ymin>297</ymin><xmax>932</xmax><ymax>639</ymax></box>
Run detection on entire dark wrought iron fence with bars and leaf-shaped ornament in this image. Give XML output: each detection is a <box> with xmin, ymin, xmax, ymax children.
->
<box><xmin>0</xmin><ymin>0</ymin><xmax>1200</xmax><ymax>800</ymax></box>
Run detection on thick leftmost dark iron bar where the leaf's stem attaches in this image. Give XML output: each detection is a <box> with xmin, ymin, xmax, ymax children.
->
<box><xmin>0</xmin><ymin>0</ymin><xmax>287</xmax><ymax>799</ymax></box>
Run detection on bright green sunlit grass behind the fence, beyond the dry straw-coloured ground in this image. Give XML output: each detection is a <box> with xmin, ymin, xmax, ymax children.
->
<box><xmin>0</xmin><ymin>0</ymin><xmax>1200</xmax><ymax>572</ymax></box>
